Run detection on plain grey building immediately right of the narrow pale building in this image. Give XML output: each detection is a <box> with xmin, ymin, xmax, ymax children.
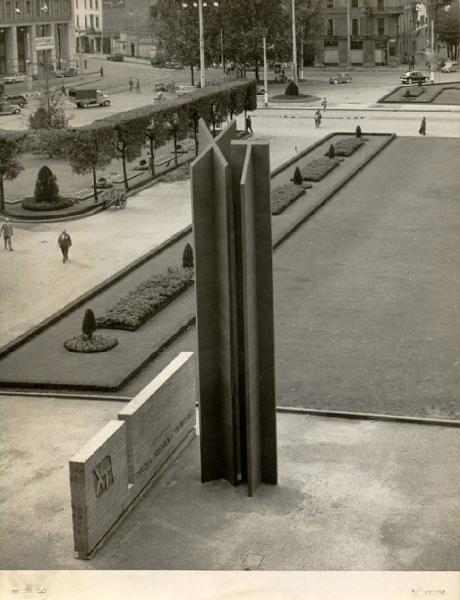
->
<box><xmin>103</xmin><ymin>0</ymin><xmax>156</xmax><ymax>58</ymax></box>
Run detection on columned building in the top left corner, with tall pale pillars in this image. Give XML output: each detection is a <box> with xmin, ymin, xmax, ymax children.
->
<box><xmin>0</xmin><ymin>0</ymin><xmax>75</xmax><ymax>77</ymax></box>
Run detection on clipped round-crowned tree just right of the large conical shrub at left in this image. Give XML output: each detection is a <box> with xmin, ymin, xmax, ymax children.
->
<box><xmin>65</xmin><ymin>126</ymin><xmax>115</xmax><ymax>202</ymax></box>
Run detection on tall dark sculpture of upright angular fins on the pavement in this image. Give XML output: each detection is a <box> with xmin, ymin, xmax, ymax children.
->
<box><xmin>191</xmin><ymin>121</ymin><xmax>277</xmax><ymax>496</ymax></box>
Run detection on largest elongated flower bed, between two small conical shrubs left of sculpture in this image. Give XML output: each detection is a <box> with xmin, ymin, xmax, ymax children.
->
<box><xmin>96</xmin><ymin>267</ymin><xmax>193</xmax><ymax>331</ymax></box>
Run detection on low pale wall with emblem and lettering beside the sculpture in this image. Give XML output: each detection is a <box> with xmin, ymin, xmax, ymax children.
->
<box><xmin>69</xmin><ymin>352</ymin><xmax>196</xmax><ymax>558</ymax></box>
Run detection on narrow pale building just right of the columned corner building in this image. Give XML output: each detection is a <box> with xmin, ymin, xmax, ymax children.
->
<box><xmin>73</xmin><ymin>0</ymin><xmax>102</xmax><ymax>53</ymax></box>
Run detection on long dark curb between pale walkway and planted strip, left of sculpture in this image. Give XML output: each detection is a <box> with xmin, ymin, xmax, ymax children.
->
<box><xmin>0</xmin><ymin>225</ymin><xmax>192</xmax><ymax>359</ymax></box>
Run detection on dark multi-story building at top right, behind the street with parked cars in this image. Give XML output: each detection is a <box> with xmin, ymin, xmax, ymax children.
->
<box><xmin>315</xmin><ymin>0</ymin><xmax>405</xmax><ymax>66</ymax></box>
